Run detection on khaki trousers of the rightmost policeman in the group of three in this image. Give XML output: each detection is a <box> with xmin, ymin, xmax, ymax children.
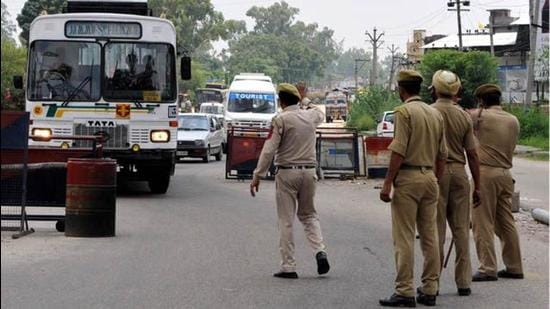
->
<box><xmin>472</xmin><ymin>165</ymin><xmax>523</xmax><ymax>276</ymax></box>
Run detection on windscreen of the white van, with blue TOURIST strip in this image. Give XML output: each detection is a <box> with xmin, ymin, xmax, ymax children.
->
<box><xmin>227</xmin><ymin>92</ymin><xmax>277</xmax><ymax>114</ymax></box>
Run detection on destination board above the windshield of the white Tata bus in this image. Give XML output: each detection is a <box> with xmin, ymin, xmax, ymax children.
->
<box><xmin>65</xmin><ymin>21</ymin><xmax>141</xmax><ymax>39</ymax></box>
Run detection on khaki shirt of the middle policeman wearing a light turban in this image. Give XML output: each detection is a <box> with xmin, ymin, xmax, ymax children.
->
<box><xmin>431</xmin><ymin>99</ymin><xmax>476</xmax><ymax>164</ymax></box>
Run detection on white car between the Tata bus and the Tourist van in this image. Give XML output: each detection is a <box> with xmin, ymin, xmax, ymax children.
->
<box><xmin>176</xmin><ymin>113</ymin><xmax>224</xmax><ymax>163</ymax></box>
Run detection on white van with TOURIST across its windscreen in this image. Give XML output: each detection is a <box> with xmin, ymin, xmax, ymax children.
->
<box><xmin>225</xmin><ymin>73</ymin><xmax>277</xmax><ymax>130</ymax></box>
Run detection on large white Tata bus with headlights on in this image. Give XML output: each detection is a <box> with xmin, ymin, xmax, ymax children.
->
<box><xmin>17</xmin><ymin>1</ymin><xmax>190</xmax><ymax>193</ymax></box>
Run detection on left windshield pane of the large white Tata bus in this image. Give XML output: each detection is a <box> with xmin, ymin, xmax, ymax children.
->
<box><xmin>27</xmin><ymin>41</ymin><xmax>101</xmax><ymax>101</ymax></box>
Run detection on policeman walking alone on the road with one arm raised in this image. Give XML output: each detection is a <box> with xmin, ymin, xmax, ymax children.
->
<box><xmin>250</xmin><ymin>83</ymin><xmax>330</xmax><ymax>279</ymax></box>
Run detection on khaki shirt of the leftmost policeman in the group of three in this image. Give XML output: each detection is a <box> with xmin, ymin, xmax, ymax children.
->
<box><xmin>388</xmin><ymin>96</ymin><xmax>447</xmax><ymax>167</ymax></box>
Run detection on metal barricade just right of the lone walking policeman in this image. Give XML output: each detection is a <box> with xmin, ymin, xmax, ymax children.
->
<box><xmin>317</xmin><ymin>127</ymin><xmax>363</xmax><ymax>178</ymax></box>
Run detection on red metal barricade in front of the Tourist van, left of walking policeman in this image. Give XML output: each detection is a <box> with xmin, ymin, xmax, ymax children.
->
<box><xmin>225</xmin><ymin>127</ymin><xmax>273</xmax><ymax>179</ymax></box>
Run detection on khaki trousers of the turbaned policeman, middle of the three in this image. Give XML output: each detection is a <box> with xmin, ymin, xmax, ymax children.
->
<box><xmin>437</xmin><ymin>163</ymin><xmax>472</xmax><ymax>289</ymax></box>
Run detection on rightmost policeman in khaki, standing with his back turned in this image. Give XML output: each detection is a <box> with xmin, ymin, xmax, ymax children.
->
<box><xmin>472</xmin><ymin>84</ymin><xmax>523</xmax><ymax>281</ymax></box>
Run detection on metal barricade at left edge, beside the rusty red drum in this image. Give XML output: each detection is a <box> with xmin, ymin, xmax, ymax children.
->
<box><xmin>0</xmin><ymin>112</ymin><xmax>104</xmax><ymax>238</ymax></box>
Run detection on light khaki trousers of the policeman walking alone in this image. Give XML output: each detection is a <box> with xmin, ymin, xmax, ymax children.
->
<box><xmin>275</xmin><ymin>168</ymin><xmax>325</xmax><ymax>272</ymax></box>
